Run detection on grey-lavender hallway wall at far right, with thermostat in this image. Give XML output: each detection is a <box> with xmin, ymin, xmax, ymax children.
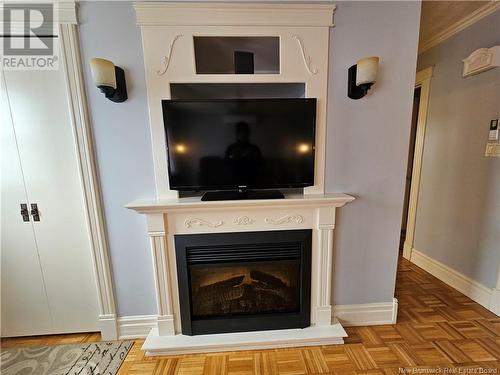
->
<box><xmin>414</xmin><ymin>11</ymin><xmax>500</xmax><ymax>288</ymax></box>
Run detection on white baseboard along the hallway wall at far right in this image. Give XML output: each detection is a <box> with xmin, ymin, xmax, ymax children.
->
<box><xmin>410</xmin><ymin>249</ymin><xmax>499</xmax><ymax>315</ymax></box>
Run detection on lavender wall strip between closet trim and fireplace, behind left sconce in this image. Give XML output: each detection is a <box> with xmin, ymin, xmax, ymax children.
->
<box><xmin>79</xmin><ymin>1</ymin><xmax>156</xmax><ymax>316</ymax></box>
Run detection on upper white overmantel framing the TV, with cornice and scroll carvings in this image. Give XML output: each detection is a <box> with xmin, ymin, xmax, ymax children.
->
<box><xmin>134</xmin><ymin>1</ymin><xmax>335</xmax><ymax>199</ymax></box>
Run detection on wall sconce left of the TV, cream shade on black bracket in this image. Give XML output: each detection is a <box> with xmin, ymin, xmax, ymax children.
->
<box><xmin>90</xmin><ymin>57</ymin><xmax>127</xmax><ymax>103</ymax></box>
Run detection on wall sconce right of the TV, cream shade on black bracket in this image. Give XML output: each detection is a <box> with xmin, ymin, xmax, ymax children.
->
<box><xmin>347</xmin><ymin>56</ymin><xmax>379</xmax><ymax>99</ymax></box>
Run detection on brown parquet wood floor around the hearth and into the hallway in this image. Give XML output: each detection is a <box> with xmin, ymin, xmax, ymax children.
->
<box><xmin>2</xmin><ymin>259</ymin><xmax>500</xmax><ymax>375</ymax></box>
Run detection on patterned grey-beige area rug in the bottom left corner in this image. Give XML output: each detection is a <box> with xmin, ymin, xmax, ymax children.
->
<box><xmin>0</xmin><ymin>341</ymin><xmax>134</xmax><ymax>375</ymax></box>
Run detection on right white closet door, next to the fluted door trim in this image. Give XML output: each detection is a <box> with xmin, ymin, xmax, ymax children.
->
<box><xmin>5</xmin><ymin>67</ymin><xmax>98</xmax><ymax>333</ymax></box>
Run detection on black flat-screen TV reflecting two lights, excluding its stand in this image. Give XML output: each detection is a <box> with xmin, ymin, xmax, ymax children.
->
<box><xmin>162</xmin><ymin>99</ymin><xmax>316</xmax><ymax>190</ymax></box>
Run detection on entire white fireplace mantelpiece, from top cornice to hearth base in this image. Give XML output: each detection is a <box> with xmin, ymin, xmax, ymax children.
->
<box><xmin>127</xmin><ymin>1</ymin><xmax>354</xmax><ymax>355</ymax></box>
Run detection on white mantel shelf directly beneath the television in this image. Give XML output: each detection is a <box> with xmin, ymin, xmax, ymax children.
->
<box><xmin>125</xmin><ymin>193</ymin><xmax>354</xmax><ymax>214</ymax></box>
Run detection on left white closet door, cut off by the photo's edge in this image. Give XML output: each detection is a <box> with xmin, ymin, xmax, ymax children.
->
<box><xmin>0</xmin><ymin>77</ymin><xmax>52</xmax><ymax>336</ymax></box>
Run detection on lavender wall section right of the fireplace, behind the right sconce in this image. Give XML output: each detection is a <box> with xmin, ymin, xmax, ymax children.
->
<box><xmin>326</xmin><ymin>1</ymin><xmax>420</xmax><ymax>304</ymax></box>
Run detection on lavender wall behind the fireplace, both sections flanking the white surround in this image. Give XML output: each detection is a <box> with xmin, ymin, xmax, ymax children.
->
<box><xmin>80</xmin><ymin>1</ymin><xmax>420</xmax><ymax>316</ymax></box>
